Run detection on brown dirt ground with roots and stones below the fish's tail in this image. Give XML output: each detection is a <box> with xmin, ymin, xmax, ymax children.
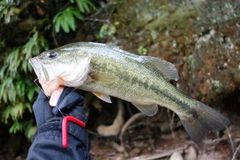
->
<box><xmin>89</xmin><ymin>109</ymin><xmax>240</xmax><ymax>160</ymax></box>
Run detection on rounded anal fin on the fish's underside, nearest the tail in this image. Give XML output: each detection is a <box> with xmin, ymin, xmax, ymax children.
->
<box><xmin>132</xmin><ymin>103</ymin><xmax>158</xmax><ymax>116</ymax></box>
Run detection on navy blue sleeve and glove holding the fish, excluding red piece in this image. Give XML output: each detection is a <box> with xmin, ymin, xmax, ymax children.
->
<box><xmin>27</xmin><ymin>88</ymin><xmax>90</xmax><ymax>160</ymax></box>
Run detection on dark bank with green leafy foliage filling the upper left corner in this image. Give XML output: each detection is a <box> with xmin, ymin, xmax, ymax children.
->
<box><xmin>0</xmin><ymin>0</ymin><xmax>99</xmax><ymax>159</ymax></box>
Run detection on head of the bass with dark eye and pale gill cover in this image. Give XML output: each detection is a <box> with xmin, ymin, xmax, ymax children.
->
<box><xmin>29</xmin><ymin>47</ymin><xmax>91</xmax><ymax>96</ymax></box>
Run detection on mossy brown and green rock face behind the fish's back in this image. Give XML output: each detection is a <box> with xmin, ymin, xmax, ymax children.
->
<box><xmin>113</xmin><ymin>0</ymin><xmax>240</xmax><ymax>107</ymax></box>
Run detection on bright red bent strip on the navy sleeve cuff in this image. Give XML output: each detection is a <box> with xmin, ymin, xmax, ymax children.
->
<box><xmin>62</xmin><ymin>116</ymin><xmax>86</xmax><ymax>148</ymax></box>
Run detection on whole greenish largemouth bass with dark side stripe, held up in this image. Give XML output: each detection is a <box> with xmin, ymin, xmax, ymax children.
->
<box><xmin>29</xmin><ymin>42</ymin><xmax>230</xmax><ymax>144</ymax></box>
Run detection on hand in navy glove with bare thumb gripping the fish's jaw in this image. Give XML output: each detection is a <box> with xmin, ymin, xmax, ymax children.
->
<box><xmin>33</xmin><ymin>87</ymin><xmax>87</xmax><ymax>127</ymax></box>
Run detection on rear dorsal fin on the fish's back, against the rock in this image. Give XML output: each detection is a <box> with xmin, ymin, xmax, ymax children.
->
<box><xmin>141</xmin><ymin>56</ymin><xmax>178</xmax><ymax>81</ymax></box>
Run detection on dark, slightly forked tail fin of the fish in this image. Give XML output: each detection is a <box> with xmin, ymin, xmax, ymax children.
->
<box><xmin>180</xmin><ymin>101</ymin><xmax>230</xmax><ymax>145</ymax></box>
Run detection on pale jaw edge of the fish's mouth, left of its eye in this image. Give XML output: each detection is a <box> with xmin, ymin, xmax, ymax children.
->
<box><xmin>29</xmin><ymin>57</ymin><xmax>49</xmax><ymax>83</ymax></box>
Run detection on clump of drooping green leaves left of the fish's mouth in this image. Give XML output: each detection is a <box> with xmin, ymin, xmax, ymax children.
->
<box><xmin>0</xmin><ymin>10</ymin><xmax>48</xmax><ymax>141</ymax></box>
